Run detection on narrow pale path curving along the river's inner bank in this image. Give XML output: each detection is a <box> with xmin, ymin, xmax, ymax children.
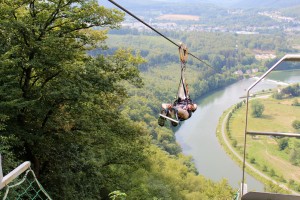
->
<box><xmin>221</xmin><ymin>112</ymin><xmax>299</xmax><ymax>194</ymax></box>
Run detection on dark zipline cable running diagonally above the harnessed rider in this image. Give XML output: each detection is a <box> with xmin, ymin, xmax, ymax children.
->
<box><xmin>108</xmin><ymin>0</ymin><xmax>215</xmax><ymax>70</ymax></box>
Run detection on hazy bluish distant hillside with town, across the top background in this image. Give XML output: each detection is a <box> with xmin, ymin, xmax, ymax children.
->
<box><xmin>100</xmin><ymin>0</ymin><xmax>300</xmax><ymax>34</ymax></box>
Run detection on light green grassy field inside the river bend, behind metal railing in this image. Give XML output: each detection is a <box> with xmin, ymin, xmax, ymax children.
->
<box><xmin>229</xmin><ymin>98</ymin><xmax>300</xmax><ymax>188</ymax></box>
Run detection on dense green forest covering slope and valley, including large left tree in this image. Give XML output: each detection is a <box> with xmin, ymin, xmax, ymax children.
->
<box><xmin>0</xmin><ymin>0</ymin><xmax>297</xmax><ymax>199</ymax></box>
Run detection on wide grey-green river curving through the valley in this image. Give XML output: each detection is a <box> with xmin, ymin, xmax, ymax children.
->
<box><xmin>176</xmin><ymin>70</ymin><xmax>300</xmax><ymax>191</ymax></box>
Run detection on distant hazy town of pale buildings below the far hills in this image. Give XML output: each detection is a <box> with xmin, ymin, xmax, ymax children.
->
<box><xmin>122</xmin><ymin>10</ymin><xmax>300</xmax><ymax>34</ymax></box>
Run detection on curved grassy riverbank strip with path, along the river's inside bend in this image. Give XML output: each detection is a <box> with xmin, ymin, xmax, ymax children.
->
<box><xmin>216</xmin><ymin>96</ymin><xmax>298</xmax><ymax>194</ymax></box>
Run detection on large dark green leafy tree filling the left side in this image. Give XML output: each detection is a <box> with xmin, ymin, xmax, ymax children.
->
<box><xmin>0</xmin><ymin>0</ymin><xmax>147</xmax><ymax>199</ymax></box>
